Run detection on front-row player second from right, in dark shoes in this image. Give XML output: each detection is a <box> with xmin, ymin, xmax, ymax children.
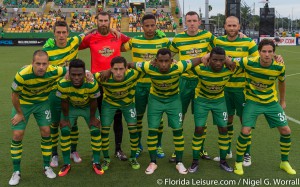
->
<box><xmin>189</xmin><ymin>47</ymin><xmax>234</xmax><ymax>173</ymax></box>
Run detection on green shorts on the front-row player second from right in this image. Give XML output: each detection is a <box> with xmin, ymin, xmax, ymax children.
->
<box><xmin>194</xmin><ymin>97</ymin><xmax>228</xmax><ymax>127</ymax></box>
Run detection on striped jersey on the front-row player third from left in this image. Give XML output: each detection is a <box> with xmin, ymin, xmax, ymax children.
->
<box><xmin>95</xmin><ymin>69</ymin><xmax>142</xmax><ymax>106</ymax></box>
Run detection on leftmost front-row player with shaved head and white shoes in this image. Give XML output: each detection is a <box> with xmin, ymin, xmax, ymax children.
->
<box><xmin>9</xmin><ymin>50</ymin><xmax>66</xmax><ymax>185</ymax></box>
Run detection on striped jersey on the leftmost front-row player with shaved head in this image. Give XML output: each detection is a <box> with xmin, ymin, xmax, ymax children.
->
<box><xmin>11</xmin><ymin>65</ymin><xmax>67</xmax><ymax>104</ymax></box>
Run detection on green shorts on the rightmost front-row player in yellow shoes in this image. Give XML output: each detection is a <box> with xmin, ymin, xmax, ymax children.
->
<box><xmin>242</xmin><ymin>100</ymin><xmax>288</xmax><ymax>128</ymax></box>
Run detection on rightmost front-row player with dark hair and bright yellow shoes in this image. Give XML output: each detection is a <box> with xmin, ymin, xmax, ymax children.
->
<box><xmin>233</xmin><ymin>39</ymin><xmax>296</xmax><ymax>175</ymax></box>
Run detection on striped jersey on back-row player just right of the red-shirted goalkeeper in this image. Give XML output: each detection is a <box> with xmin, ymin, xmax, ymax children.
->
<box><xmin>125</xmin><ymin>35</ymin><xmax>171</xmax><ymax>87</ymax></box>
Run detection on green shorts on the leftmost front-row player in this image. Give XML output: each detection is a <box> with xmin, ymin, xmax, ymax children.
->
<box><xmin>11</xmin><ymin>101</ymin><xmax>51</xmax><ymax>130</ymax></box>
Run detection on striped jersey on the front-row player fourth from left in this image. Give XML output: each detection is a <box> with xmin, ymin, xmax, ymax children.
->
<box><xmin>135</xmin><ymin>60</ymin><xmax>192</xmax><ymax>99</ymax></box>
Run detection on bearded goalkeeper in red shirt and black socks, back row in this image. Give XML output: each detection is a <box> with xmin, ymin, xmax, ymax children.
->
<box><xmin>79</xmin><ymin>12</ymin><xmax>130</xmax><ymax>161</ymax></box>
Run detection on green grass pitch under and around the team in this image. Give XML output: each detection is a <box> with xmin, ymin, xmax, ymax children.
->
<box><xmin>0</xmin><ymin>46</ymin><xmax>300</xmax><ymax>187</ymax></box>
